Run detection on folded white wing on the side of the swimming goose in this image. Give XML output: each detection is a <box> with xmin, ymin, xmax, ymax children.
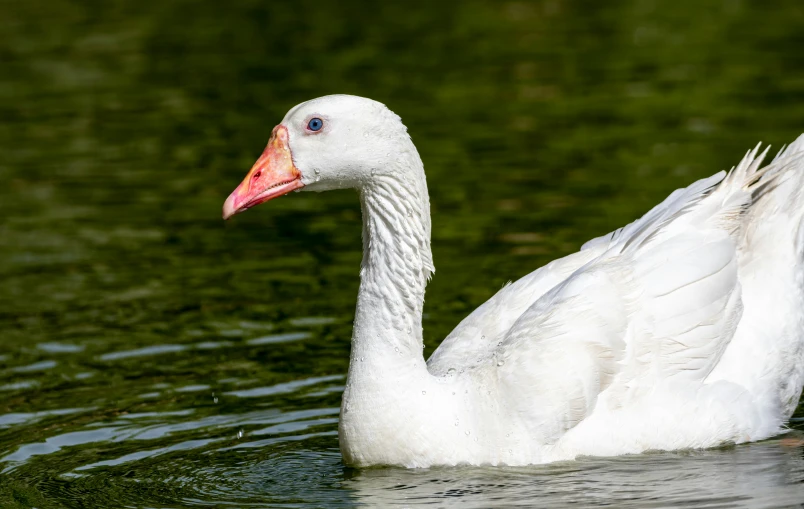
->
<box><xmin>490</xmin><ymin>147</ymin><xmax>780</xmax><ymax>436</ymax></box>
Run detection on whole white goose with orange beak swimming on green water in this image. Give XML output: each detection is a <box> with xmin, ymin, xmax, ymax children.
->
<box><xmin>223</xmin><ymin>95</ymin><xmax>804</xmax><ymax>467</ymax></box>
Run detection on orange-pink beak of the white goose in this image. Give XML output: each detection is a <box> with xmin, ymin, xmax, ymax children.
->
<box><xmin>223</xmin><ymin>125</ymin><xmax>304</xmax><ymax>219</ymax></box>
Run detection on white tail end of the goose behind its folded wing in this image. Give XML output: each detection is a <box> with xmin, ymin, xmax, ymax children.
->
<box><xmin>714</xmin><ymin>135</ymin><xmax>804</xmax><ymax>423</ymax></box>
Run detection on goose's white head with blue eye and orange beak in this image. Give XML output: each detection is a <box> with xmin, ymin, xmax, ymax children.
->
<box><xmin>223</xmin><ymin>95</ymin><xmax>418</xmax><ymax>219</ymax></box>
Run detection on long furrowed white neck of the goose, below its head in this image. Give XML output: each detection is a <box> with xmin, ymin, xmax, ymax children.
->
<box><xmin>349</xmin><ymin>145</ymin><xmax>434</xmax><ymax>372</ymax></box>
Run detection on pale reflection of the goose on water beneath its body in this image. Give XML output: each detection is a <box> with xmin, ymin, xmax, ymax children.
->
<box><xmin>346</xmin><ymin>443</ymin><xmax>804</xmax><ymax>507</ymax></box>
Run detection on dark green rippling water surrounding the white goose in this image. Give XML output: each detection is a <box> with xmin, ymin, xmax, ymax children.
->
<box><xmin>0</xmin><ymin>0</ymin><xmax>804</xmax><ymax>508</ymax></box>
